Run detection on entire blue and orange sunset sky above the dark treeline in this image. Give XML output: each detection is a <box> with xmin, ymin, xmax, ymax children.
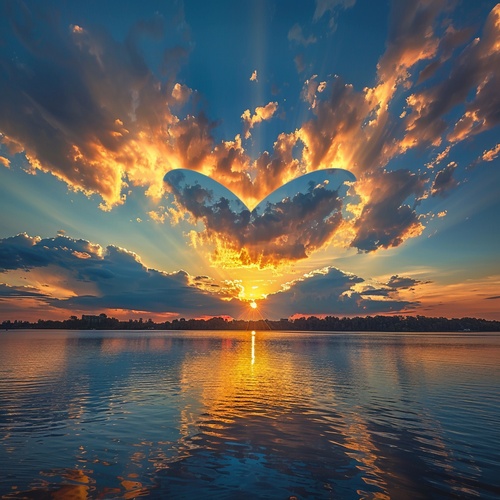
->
<box><xmin>0</xmin><ymin>0</ymin><xmax>500</xmax><ymax>321</ymax></box>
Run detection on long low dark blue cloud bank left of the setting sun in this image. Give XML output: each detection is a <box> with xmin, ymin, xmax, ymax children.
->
<box><xmin>0</xmin><ymin>234</ymin><xmax>241</xmax><ymax>315</ymax></box>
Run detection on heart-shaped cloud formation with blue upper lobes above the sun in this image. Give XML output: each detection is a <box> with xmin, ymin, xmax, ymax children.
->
<box><xmin>164</xmin><ymin>168</ymin><xmax>356</xmax><ymax>268</ymax></box>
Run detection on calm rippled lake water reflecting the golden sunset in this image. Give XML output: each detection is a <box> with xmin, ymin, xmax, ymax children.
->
<box><xmin>0</xmin><ymin>331</ymin><xmax>500</xmax><ymax>499</ymax></box>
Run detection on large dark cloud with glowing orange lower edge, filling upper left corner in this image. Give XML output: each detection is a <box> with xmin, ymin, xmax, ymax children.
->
<box><xmin>0</xmin><ymin>3</ymin><xmax>204</xmax><ymax>208</ymax></box>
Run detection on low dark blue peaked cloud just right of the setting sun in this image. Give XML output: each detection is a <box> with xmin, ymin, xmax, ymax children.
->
<box><xmin>262</xmin><ymin>267</ymin><xmax>416</xmax><ymax>316</ymax></box>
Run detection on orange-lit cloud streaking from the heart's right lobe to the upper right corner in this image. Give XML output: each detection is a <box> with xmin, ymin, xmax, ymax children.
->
<box><xmin>290</xmin><ymin>0</ymin><xmax>500</xmax><ymax>251</ymax></box>
